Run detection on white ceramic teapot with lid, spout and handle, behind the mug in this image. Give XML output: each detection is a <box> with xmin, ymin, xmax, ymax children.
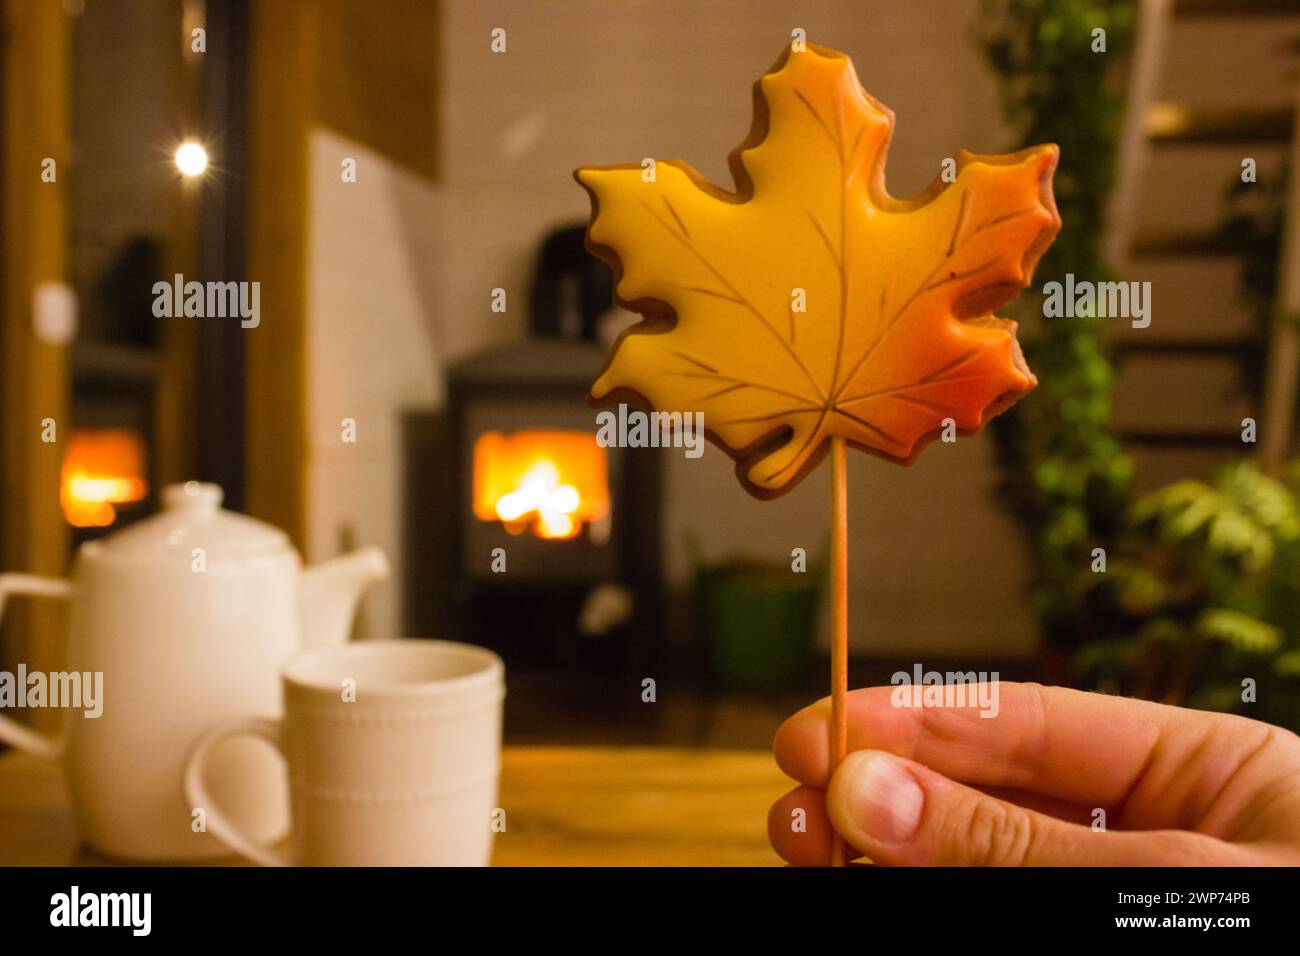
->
<box><xmin>0</xmin><ymin>481</ymin><xmax>389</xmax><ymax>860</ymax></box>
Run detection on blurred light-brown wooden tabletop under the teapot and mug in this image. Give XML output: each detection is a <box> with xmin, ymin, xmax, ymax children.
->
<box><xmin>0</xmin><ymin>747</ymin><xmax>793</xmax><ymax>866</ymax></box>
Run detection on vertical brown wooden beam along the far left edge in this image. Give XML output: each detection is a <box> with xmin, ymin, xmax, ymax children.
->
<box><xmin>0</xmin><ymin>0</ymin><xmax>72</xmax><ymax>724</ymax></box>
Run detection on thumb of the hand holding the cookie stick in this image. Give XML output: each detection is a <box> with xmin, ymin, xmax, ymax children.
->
<box><xmin>827</xmin><ymin>750</ymin><xmax>1249</xmax><ymax>866</ymax></box>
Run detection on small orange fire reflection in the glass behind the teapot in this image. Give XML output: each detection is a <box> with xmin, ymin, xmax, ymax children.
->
<box><xmin>60</xmin><ymin>428</ymin><xmax>148</xmax><ymax>528</ymax></box>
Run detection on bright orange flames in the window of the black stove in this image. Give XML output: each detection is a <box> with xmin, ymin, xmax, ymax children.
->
<box><xmin>473</xmin><ymin>431</ymin><xmax>610</xmax><ymax>538</ymax></box>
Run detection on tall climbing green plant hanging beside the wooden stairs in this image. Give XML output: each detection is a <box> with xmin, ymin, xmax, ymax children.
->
<box><xmin>979</xmin><ymin>0</ymin><xmax>1135</xmax><ymax>660</ymax></box>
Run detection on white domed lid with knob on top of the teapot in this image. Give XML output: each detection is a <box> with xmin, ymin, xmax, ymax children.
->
<box><xmin>83</xmin><ymin>481</ymin><xmax>290</xmax><ymax>563</ymax></box>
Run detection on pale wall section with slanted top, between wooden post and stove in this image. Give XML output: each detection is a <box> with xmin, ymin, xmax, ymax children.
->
<box><xmin>302</xmin><ymin>129</ymin><xmax>441</xmax><ymax>637</ymax></box>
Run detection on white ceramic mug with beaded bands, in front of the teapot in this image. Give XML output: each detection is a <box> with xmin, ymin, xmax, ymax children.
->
<box><xmin>183</xmin><ymin>640</ymin><xmax>504</xmax><ymax>866</ymax></box>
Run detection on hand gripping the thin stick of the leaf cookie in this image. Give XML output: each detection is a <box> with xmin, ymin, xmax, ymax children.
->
<box><xmin>767</xmin><ymin>682</ymin><xmax>1300</xmax><ymax>866</ymax></box>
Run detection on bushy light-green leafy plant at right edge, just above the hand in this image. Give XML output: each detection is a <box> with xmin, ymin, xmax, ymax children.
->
<box><xmin>1076</xmin><ymin>462</ymin><xmax>1300</xmax><ymax>728</ymax></box>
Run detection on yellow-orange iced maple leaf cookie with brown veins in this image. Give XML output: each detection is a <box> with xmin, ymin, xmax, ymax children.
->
<box><xmin>575</xmin><ymin>44</ymin><xmax>1061</xmax><ymax>498</ymax></box>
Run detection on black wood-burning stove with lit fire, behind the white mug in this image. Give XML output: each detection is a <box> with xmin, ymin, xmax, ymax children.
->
<box><xmin>443</xmin><ymin>338</ymin><xmax>660</xmax><ymax>671</ymax></box>
